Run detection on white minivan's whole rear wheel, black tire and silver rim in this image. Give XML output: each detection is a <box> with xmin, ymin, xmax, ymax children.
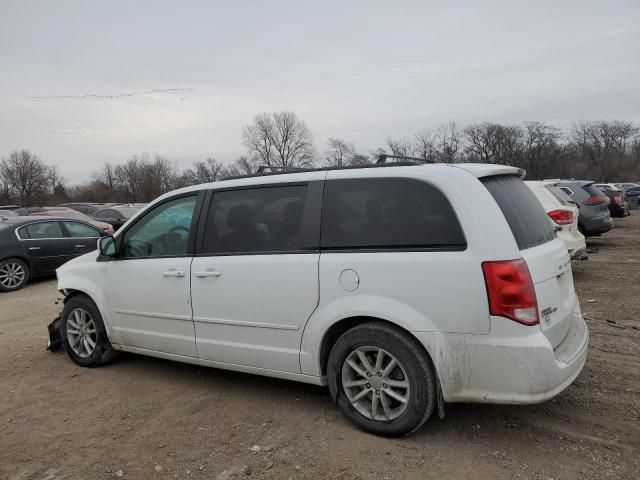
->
<box><xmin>327</xmin><ymin>322</ymin><xmax>437</xmax><ymax>437</ymax></box>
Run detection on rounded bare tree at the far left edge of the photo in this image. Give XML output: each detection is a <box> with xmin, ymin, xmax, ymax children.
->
<box><xmin>0</xmin><ymin>150</ymin><xmax>49</xmax><ymax>206</ymax></box>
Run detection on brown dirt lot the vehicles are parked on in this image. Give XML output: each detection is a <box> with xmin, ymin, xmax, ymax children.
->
<box><xmin>0</xmin><ymin>218</ymin><xmax>640</xmax><ymax>480</ymax></box>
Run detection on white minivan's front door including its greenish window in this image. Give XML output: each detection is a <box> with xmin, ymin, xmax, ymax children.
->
<box><xmin>107</xmin><ymin>195</ymin><xmax>198</xmax><ymax>357</ymax></box>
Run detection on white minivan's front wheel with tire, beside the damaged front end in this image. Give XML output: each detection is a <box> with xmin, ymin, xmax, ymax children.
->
<box><xmin>60</xmin><ymin>295</ymin><xmax>118</xmax><ymax>367</ymax></box>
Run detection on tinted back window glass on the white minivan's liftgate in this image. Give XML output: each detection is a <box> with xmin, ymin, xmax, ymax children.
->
<box><xmin>480</xmin><ymin>175</ymin><xmax>555</xmax><ymax>250</ymax></box>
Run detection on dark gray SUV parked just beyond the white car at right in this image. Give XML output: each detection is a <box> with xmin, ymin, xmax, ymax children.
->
<box><xmin>558</xmin><ymin>180</ymin><xmax>613</xmax><ymax>237</ymax></box>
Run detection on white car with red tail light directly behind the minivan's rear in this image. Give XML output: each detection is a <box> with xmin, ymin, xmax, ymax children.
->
<box><xmin>524</xmin><ymin>180</ymin><xmax>587</xmax><ymax>260</ymax></box>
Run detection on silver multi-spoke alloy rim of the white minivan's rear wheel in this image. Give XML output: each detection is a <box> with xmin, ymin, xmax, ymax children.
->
<box><xmin>342</xmin><ymin>346</ymin><xmax>411</xmax><ymax>422</ymax></box>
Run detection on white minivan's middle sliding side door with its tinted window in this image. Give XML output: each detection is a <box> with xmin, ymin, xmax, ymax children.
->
<box><xmin>191</xmin><ymin>182</ymin><xmax>322</xmax><ymax>373</ymax></box>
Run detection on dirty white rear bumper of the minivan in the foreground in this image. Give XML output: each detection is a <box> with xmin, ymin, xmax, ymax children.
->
<box><xmin>415</xmin><ymin>306</ymin><xmax>589</xmax><ymax>404</ymax></box>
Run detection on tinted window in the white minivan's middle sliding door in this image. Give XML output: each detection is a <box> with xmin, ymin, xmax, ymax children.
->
<box><xmin>203</xmin><ymin>185</ymin><xmax>307</xmax><ymax>254</ymax></box>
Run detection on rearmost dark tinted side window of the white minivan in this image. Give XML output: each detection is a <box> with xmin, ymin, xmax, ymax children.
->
<box><xmin>320</xmin><ymin>178</ymin><xmax>466</xmax><ymax>249</ymax></box>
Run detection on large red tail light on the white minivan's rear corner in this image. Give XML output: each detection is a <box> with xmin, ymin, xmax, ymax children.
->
<box><xmin>482</xmin><ymin>259</ymin><xmax>539</xmax><ymax>325</ymax></box>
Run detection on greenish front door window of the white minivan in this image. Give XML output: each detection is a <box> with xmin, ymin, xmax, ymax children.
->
<box><xmin>121</xmin><ymin>195</ymin><xmax>196</xmax><ymax>258</ymax></box>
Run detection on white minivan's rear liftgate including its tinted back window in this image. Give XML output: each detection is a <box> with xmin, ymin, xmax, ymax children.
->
<box><xmin>480</xmin><ymin>175</ymin><xmax>578</xmax><ymax>348</ymax></box>
